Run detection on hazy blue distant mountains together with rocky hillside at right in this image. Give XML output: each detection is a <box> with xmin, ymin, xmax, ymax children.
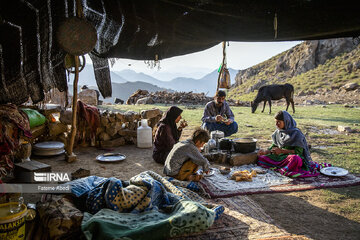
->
<box><xmin>74</xmin><ymin>38</ymin><xmax>360</xmax><ymax>102</ymax></box>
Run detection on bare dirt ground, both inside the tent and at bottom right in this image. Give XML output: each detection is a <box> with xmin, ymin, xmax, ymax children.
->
<box><xmin>28</xmin><ymin>133</ymin><xmax>360</xmax><ymax>239</ymax></box>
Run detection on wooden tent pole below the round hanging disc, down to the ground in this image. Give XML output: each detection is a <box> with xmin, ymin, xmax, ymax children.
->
<box><xmin>66</xmin><ymin>56</ymin><xmax>80</xmax><ymax>162</ymax></box>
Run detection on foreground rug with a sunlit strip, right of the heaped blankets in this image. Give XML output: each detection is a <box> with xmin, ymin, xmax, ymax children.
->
<box><xmin>172</xmin><ymin>196</ymin><xmax>307</xmax><ymax>240</ymax></box>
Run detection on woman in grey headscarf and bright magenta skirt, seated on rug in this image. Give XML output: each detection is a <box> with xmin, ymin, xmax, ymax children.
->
<box><xmin>258</xmin><ymin>111</ymin><xmax>331</xmax><ymax>177</ymax></box>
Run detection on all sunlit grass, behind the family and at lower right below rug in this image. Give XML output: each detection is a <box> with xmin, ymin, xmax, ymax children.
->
<box><xmin>103</xmin><ymin>105</ymin><xmax>360</xmax><ymax>223</ymax></box>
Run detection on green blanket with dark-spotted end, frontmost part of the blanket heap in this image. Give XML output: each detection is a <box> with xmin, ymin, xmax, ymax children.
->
<box><xmin>82</xmin><ymin>200</ymin><xmax>215</xmax><ymax>240</ymax></box>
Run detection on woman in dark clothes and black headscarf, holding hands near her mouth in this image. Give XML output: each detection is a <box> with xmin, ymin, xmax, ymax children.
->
<box><xmin>153</xmin><ymin>106</ymin><xmax>187</xmax><ymax>164</ymax></box>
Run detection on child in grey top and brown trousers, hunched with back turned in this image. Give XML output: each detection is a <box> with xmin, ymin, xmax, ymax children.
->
<box><xmin>164</xmin><ymin>129</ymin><xmax>210</xmax><ymax>181</ymax></box>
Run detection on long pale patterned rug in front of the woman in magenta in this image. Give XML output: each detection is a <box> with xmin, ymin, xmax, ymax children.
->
<box><xmin>200</xmin><ymin>168</ymin><xmax>360</xmax><ymax>198</ymax></box>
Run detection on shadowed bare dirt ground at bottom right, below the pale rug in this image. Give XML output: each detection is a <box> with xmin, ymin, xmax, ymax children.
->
<box><xmin>251</xmin><ymin>189</ymin><xmax>360</xmax><ymax>240</ymax></box>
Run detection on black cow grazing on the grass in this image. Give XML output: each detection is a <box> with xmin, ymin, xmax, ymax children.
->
<box><xmin>251</xmin><ymin>83</ymin><xmax>295</xmax><ymax>114</ymax></box>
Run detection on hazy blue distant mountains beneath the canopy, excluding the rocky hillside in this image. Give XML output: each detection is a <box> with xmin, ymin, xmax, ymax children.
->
<box><xmin>79</xmin><ymin>64</ymin><xmax>237</xmax><ymax>102</ymax></box>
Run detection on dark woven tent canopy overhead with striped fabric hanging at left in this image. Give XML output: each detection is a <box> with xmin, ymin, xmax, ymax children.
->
<box><xmin>0</xmin><ymin>0</ymin><xmax>360</xmax><ymax>104</ymax></box>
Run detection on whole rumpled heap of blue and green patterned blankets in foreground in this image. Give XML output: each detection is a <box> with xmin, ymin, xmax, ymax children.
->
<box><xmin>67</xmin><ymin>171</ymin><xmax>224</xmax><ymax>239</ymax></box>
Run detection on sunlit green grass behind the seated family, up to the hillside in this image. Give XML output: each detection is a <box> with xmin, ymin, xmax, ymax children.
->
<box><xmin>103</xmin><ymin>105</ymin><xmax>360</xmax><ymax>173</ymax></box>
